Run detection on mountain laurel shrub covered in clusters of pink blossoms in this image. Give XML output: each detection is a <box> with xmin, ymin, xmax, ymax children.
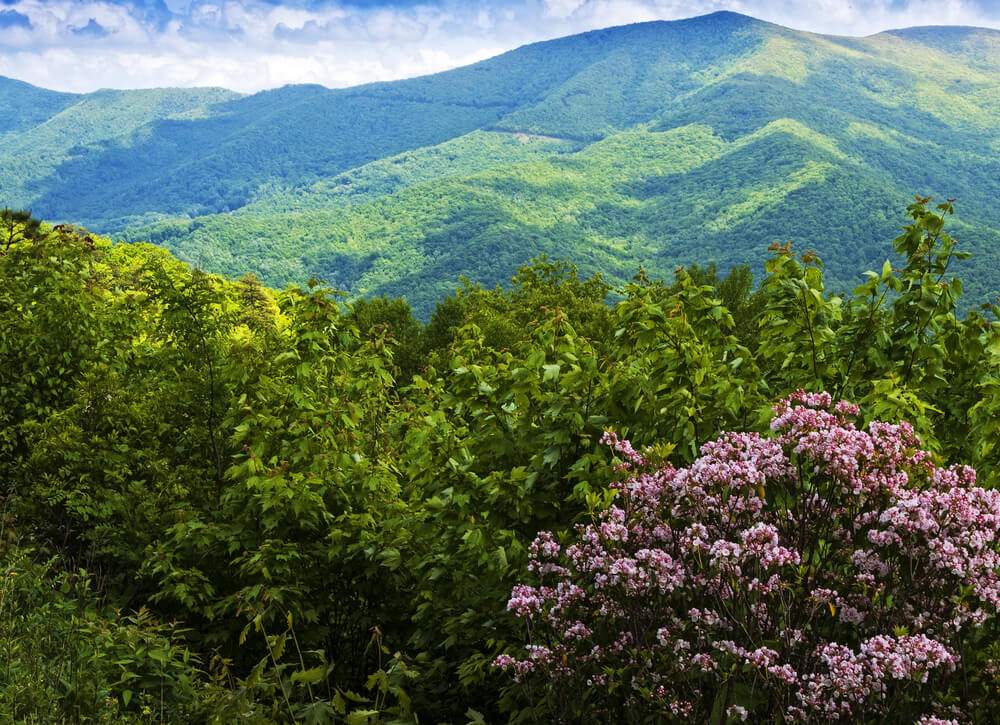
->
<box><xmin>495</xmin><ymin>391</ymin><xmax>1000</xmax><ymax>723</ymax></box>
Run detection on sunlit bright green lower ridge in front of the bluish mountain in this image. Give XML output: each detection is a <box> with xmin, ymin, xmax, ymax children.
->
<box><xmin>128</xmin><ymin>120</ymin><xmax>976</xmax><ymax>314</ymax></box>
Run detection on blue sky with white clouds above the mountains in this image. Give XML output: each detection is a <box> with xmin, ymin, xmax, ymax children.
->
<box><xmin>0</xmin><ymin>0</ymin><xmax>1000</xmax><ymax>92</ymax></box>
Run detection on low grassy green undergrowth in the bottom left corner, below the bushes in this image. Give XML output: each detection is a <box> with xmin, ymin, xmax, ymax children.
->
<box><xmin>0</xmin><ymin>528</ymin><xmax>220</xmax><ymax>723</ymax></box>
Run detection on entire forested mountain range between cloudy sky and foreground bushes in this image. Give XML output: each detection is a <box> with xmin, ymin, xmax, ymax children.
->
<box><xmin>0</xmin><ymin>12</ymin><xmax>1000</xmax><ymax>315</ymax></box>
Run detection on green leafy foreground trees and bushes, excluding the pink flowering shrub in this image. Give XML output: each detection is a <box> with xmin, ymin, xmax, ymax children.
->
<box><xmin>9</xmin><ymin>198</ymin><xmax>1000</xmax><ymax>723</ymax></box>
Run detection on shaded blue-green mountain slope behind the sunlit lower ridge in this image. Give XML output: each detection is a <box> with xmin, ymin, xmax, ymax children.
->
<box><xmin>0</xmin><ymin>14</ymin><xmax>753</xmax><ymax>231</ymax></box>
